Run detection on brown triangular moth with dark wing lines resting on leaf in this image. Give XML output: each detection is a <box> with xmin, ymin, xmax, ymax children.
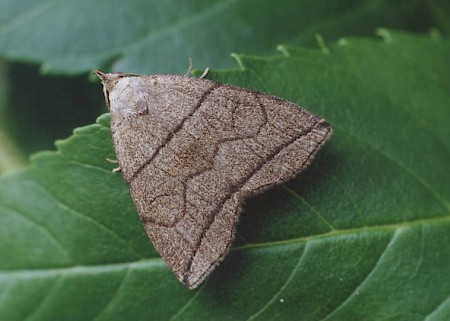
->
<box><xmin>95</xmin><ymin>70</ymin><xmax>332</xmax><ymax>289</ymax></box>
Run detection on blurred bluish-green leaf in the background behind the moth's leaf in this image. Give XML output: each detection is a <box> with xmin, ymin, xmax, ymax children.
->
<box><xmin>0</xmin><ymin>0</ymin><xmax>440</xmax><ymax>73</ymax></box>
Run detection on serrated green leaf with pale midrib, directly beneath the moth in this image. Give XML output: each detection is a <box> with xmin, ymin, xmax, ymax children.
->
<box><xmin>0</xmin><ymin>29</ymin><xmax>450</xmax><ymax>321</ymax></box>
